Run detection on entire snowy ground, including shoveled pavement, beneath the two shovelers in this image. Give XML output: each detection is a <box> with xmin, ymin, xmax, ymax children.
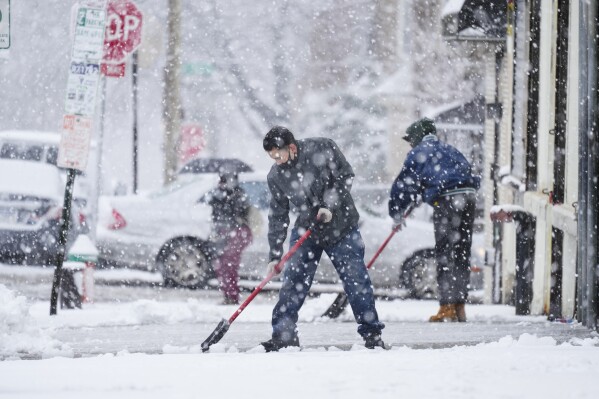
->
<box><xmin>0</xmin><ymin>265</ymin><xmax>599</xmax><ymax>399</ymax></box>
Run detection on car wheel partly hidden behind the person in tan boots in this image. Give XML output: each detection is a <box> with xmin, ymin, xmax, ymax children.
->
<box><xmin>399</xmin><ymin>249</ymin><xmax>438</xmax><ymax>299</ymax></box>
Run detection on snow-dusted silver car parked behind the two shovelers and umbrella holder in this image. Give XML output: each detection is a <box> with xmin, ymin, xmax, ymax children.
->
<box><xmin>97</xmin><ymin>173</ymin><xmax>486</xmax><ymax>298</ymax></box>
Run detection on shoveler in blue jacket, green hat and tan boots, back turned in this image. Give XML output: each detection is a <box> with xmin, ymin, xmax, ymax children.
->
<box><xmin>389</xmin><ymin>118</ymin><xmax>480</xmax><ymax>322</ymax></box>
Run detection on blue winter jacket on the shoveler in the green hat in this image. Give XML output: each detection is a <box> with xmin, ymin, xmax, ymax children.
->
<box><xmin>389</xmin><ymin>134</ymin><xmax>480</xmax><ymax>218</ymax></box>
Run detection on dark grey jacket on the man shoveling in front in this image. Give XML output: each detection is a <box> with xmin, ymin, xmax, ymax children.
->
<box><xmin>268</xmin><ymin>137</ymin><xmax>360</xmax><ymax>260</ymax></box>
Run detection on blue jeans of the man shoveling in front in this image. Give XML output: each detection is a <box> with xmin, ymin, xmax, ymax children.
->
<box><xmin>272</xmin><ymin>227</ymin><xmax>385</xmax><ymax>342</ymax></box>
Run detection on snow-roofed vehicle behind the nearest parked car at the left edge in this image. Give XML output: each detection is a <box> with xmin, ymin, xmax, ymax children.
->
<box><xmin>0</xmin><ymin>130</ymin><xmax>90</xmax><ymax>233</ymax></box>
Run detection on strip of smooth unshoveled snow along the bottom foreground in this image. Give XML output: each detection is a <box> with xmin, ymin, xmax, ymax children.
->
<box><xmin>0</xmin><ymin>336</ymin><xmax>599</xmax><ymax>399</ymax></box>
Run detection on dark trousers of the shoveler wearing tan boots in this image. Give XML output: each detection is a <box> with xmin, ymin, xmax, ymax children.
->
<box><xmin>433</xmin><ymin>194</ymin><xmax>476</xmax><ymax>305</ymax></box>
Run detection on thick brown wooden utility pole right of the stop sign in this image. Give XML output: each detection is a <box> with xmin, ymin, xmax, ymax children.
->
<box><xmin>163</xmin><ymin>0</ymin><xmax>181</xmax><ymax>185</ymax></box>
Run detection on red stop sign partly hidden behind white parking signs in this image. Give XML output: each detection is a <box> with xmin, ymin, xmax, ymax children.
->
<box><xmin>102</xmin><ymin>0</ymin><xmax>142</xmax><ymax>64</ymax></box>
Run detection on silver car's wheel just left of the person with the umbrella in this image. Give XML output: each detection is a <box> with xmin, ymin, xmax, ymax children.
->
<box><xmin>158</xmin><ymin>238</ymin><xmax>214</xmax><ymax>288</ymax></box>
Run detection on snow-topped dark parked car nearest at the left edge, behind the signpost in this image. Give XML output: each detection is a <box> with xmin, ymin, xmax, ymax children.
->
<box><xmin>0</xmin><ymin>159</ymin><xmax>77</xmax><ymax>265</ymax></box>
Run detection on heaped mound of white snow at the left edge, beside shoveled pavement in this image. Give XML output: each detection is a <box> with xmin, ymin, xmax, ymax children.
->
<box><xmin>0</xmin><ymin>284</ymin><xmax>72</xmax><ymax>357</ymax></box>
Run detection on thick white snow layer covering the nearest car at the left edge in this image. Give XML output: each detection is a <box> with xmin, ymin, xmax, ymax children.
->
<box><xmin>0</xmin><ymin>159</ymin><xmax>64</xmax><ymax>201</ymax></box>
